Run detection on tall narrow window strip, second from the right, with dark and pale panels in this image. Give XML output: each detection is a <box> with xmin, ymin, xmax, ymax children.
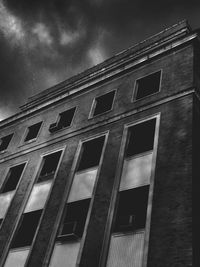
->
<box><xmin>49</xmin><ymin>136</ymin><xmax>105</xmax><ymax>267</ymax></box>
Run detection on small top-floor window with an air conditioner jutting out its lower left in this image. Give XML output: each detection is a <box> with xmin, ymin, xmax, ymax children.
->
<box><xmin>49</xmin><ymin>107</ymin><xmax>76</xmax><ymax>133</ymax></box>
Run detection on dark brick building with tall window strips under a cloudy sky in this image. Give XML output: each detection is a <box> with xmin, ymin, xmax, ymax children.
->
<box><xmin>0</xmin><ymin>21</ymin><xmax>197</xmax><ymax>267</ymax></box>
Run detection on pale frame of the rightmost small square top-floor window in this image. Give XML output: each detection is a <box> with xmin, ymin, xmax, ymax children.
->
<box><xmin>131</xmin><ymin>68</ymin><xmax>163</xmax><ymax>102</ymax></box>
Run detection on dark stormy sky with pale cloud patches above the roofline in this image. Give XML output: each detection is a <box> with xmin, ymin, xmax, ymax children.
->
<box><xmin>0</xmin><ymin>0</ymin><xmax>200</xmax><ymax>120</ymax></box>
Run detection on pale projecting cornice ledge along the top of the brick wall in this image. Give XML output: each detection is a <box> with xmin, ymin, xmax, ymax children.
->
<box><xmin>0</xmin><ymin>24</ymin><xmax>198</xmax><ymax>128</ymax></box>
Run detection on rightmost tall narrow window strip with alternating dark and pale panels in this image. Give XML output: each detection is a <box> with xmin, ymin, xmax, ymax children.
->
<box><xmin>107</xmin><ymin>119</ymin><xmax>156</xmax><ymax>267</ymax></box>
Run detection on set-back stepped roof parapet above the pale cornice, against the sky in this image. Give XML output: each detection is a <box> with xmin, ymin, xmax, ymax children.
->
<box><xmin>20</xmin><ymin>20</ymin><xmax>192</xmax><ymax>111</ymax></box>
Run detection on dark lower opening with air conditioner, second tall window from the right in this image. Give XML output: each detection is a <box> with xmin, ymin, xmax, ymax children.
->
<box><xmin>58</xmin><ymin>199</ymin><xmax>90</xmax><ymax>241</ymax></box>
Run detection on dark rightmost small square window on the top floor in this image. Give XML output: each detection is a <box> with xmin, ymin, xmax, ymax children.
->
<box><xmin>135</xmin><ymin>71</ymin><xmax>161</xmax><ymax>100</ymax></box>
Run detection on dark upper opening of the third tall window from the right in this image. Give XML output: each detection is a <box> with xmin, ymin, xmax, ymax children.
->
<box><xmin>38</xmin><ymin>151</ymin><xmax>62</xmax><ymax>182</ymax></box>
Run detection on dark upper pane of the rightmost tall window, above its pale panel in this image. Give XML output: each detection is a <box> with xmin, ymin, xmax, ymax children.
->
<box><xmin>126</xmin><ymin>119</ymin><xmax>156</xmax><ymax>157</ymax></box>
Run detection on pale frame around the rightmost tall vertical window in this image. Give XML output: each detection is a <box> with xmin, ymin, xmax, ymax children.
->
<box><xmin>99</xmin><ymin>112</ymin><xmax>161</xmax><ymax>267</ymax></box>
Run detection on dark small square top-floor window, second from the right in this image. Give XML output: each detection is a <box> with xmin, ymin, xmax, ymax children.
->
<box><xmin>93</xmin><ymin>91</ymin><xmax>115</xmax><ymax>116</ymax></box>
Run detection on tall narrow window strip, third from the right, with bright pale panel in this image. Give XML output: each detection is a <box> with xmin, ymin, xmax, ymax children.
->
<box><xmin>5</xmin><ymin>151</ymin><xmax>62</xmax><ymax>267</ymax></box>
